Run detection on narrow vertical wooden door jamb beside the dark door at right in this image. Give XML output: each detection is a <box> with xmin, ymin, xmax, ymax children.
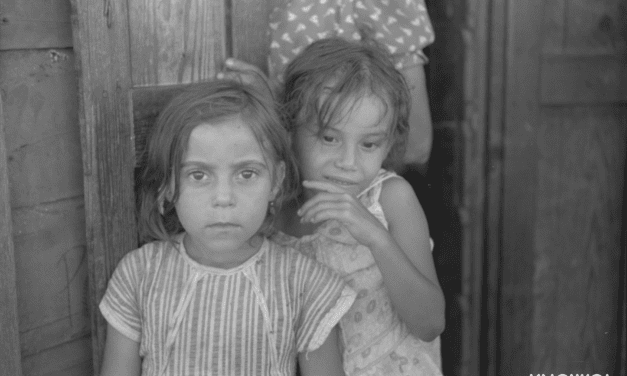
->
<box><xmin>459</xmin><ymin>1</ymin><xmax>491</xmax><ymax>376</ymax></box>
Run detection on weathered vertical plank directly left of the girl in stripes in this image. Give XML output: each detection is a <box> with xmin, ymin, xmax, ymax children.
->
<box><xmin>72</xmin><ymin>0</ymin><xmax>137</xmax><ymax>375</ymax></box>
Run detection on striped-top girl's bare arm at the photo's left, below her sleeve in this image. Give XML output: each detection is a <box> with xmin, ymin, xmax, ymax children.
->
<box><xmin>100</xmin><ymin>324</ymin><xmax>141</xmax><ymax>376</ymax></box>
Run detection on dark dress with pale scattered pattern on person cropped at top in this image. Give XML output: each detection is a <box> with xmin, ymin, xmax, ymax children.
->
<box><xmin>268</xmin><ymin>0</ymin><xmax>435</xmax><ymax>82</ymax></box>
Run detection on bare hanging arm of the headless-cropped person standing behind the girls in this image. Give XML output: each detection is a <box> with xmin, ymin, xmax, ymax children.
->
<box><xmin>402</xmin><ymin>65</ymin><xmax>433</xmax><ymax>174</ymax></box>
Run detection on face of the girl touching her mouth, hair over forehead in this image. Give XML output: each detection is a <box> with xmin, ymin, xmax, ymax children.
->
<box><xmin>294</xmin><ymin>95</ymin><xmax>392</xmax><ymax>197</ymax></box>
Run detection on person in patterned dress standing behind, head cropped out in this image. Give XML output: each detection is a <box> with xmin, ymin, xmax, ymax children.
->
<box><xmin>268</xmin><ymin>0</ymin><xmax>435</xmax><ymax>172</ymax></box>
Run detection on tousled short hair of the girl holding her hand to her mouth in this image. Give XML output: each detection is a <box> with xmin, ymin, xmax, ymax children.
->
<box><xmin>281</xmin><ymin>37</ymin><xmax>411</xmax><ymax>169</ymax></box>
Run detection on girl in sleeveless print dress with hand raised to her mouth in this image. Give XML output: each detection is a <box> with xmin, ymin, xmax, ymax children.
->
<box><xmin>275</xmin><ymin>38</ymin><xmax>444</xmax><ymax>376</ymax></box>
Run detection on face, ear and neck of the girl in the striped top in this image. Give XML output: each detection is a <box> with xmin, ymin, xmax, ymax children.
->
<box><xmin>175</xmin><ymin>117</ymin><xmax>284</xmax><ymax>264</ymax></box>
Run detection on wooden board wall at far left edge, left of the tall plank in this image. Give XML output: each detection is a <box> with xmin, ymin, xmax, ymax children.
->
<box><xmin>0</xmin><ymin>0</ymin><xmax>91</xmax><ymax>376</ymax></box>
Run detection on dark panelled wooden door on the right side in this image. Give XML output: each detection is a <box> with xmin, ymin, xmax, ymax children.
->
<box><xmin>482</xmin><ymin>0</ymin><xmax>627</xmax><ymax>375</ymax></box>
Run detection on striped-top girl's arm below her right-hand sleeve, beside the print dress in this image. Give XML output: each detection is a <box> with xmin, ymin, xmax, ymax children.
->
<box><xmin>298</xmin><ymin>326</ymin><xmax>344</xmax><ymax>376</ymax></box>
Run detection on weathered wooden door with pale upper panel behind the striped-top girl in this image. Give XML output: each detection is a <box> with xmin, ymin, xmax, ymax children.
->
<box><xmin>72</xmin><ymin>0</ymin><xmax>280</xmax><ymax>373</ymax></box>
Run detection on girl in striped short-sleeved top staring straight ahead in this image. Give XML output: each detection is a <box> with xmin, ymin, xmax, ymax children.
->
<box><xmin>100</xmin><ymin>81</ymin><xmax>355</xmax><ymax>376</ymax></box>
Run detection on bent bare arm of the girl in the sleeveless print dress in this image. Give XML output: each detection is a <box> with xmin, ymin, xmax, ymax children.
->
<box><xmin>370</xmin><ymin>179</ymin><xmax>445</xmax><ymax>341</ymax></box>
